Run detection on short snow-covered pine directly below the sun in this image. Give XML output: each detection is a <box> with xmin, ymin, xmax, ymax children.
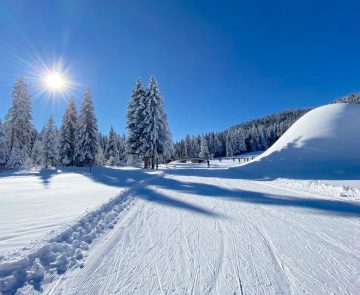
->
<box><xmin>42</xmin><ymin>115</ymin><xmax>59</xmax><ymax>168</ymax></box>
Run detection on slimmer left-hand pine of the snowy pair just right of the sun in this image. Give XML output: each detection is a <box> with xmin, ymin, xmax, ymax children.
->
<box><xmin>59</xmin><ymin>97</ymin><xmax>78</xmax><ymax>166</ymax></box>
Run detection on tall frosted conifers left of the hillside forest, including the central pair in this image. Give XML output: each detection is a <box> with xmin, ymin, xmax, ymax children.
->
<box><xmin>0</xmin><ymin>77</ymin><xmax>173</xmax><ymax>169</ymax></box>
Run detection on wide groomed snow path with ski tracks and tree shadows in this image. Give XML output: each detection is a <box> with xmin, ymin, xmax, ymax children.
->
<box><xmin>45</xmin><ymin>169</ymin><xmax>360</xmax><ymax>294</ymax></box>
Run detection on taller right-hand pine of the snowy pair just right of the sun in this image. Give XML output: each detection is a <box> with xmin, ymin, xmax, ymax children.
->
<box><xmin>74</xmin><ymin>88</ymin><xmax>99</xmax><ymax>171</ymax></box>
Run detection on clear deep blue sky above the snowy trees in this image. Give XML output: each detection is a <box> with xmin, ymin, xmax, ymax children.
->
<box><xmin>0</xmin><ymin>0</ymin><xmax>360</xmax><ymax>140</ymax></box>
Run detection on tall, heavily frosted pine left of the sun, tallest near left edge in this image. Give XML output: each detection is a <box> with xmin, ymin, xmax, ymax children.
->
<box><xmin>6</xmin><ymin>77</ymin><xmax>33</xmax><ymax>167</ymax></box>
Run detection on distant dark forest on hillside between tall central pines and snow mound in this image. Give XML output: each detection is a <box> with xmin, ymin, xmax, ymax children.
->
<box><xmin>174</xmin><ymin>108</ymin><xmax>310</xmax><ymax>159</ymax></box>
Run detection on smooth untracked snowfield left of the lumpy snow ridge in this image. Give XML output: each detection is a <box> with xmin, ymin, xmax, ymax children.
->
<box><xmin>0</xmin><ymin>167</ymin><xmax>159</xmax><ymax>256</ymax></box>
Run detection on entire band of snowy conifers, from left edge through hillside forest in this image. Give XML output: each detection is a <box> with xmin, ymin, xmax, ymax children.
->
<box><xmin>0</xmin><ymin>77</ymin><xmax>352</xmax><ymax>169</ymax></box>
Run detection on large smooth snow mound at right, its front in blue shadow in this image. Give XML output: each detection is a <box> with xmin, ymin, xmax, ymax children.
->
<box><xmin>241</xmin><ymin>103</ymin><xmax>360</xmax><ymax>179</ymax></box>
